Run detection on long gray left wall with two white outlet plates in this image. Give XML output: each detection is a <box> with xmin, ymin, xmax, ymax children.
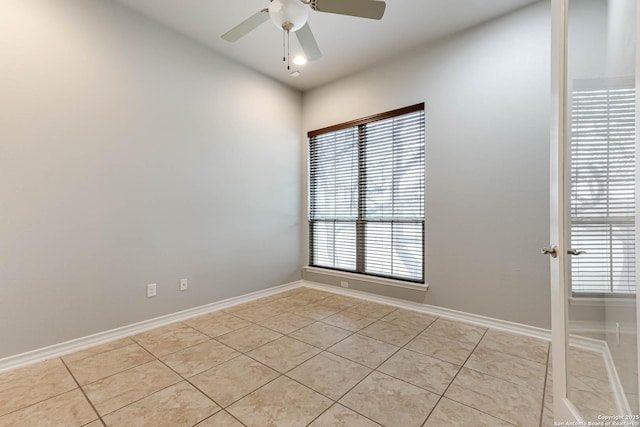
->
<box><xmin>0</xmin><ymin>0</ymin><xmax>301</xmax><ymax>358</ymax></box>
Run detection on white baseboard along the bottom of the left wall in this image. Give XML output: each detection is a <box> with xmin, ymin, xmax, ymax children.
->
<box><xmin>0</xmin><ymin>280</ymin><xmax>302</xmax><ymax>372</ymax></box>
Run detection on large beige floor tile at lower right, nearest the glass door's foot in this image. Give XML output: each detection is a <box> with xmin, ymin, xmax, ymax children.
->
<box><xmin>445</xmin><ymin>368</ymin><xmax>542</xmax><ymax>427</ymax></box>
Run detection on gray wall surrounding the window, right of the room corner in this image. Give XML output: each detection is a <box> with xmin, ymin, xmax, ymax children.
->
<box><xmin>301</xmin><ymin>2</ymin><xmax>550</xmax><ymax>328</ymax></box>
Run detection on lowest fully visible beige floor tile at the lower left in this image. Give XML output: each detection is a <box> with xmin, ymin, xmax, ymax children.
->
<box><xmin>82</xmin><ymin>361</ymin><xmax>181</xmax><ymax>415</ymax></box>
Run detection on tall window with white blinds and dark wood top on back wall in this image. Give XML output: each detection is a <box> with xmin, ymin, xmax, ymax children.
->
<box><xmin>309</xmin><ymin>104</ymin><xmax>424</xmax><ymax>283</ymax></box>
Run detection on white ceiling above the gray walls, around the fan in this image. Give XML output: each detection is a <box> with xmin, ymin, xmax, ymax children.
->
<box><xmin>116</xmin><ymin>0</ymin><xmax>536</xmax><ymax>90</ymax></box>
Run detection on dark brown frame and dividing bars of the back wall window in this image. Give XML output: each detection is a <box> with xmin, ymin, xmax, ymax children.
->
<box><xmin>307</xmin><ymin>102</ymin><xmax>426</xmax><ymax>287</ymax></box>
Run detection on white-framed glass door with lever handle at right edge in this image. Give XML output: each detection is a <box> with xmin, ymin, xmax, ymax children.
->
<box><xmin>543</xmin><ymin>0</ymin><xmax>640</xmax><ymax>421</ymax></box>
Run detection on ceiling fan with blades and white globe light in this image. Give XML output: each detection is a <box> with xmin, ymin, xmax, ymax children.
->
<box><xmin>222</xmin><ymin>0</ymin><xmax>386</xmax><ymax>65</ymax></box>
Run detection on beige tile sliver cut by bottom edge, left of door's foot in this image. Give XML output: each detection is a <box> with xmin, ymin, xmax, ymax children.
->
<box><xmin>424</xmin><ymin>397</ymin><xmax>516</xmax><ymax>427</ymax></box>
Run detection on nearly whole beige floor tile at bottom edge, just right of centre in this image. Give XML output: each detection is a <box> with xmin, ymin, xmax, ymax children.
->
<box><xmin>340</xmin><ymin>372</ymin><xmax>438</xmax><ymax>427</ymax></box>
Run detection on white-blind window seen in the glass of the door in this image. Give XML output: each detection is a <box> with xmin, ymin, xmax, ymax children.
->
<box><xmin>570</xmin><ymin>79</ymin><xmax>635</xmax><ymax>294</ymax></box>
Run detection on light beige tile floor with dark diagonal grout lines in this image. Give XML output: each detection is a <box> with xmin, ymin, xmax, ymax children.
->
<box><xmin>0</xmin><ymin>288</ymin><xmax>608</xmax><ymax>427</ymax></box>
